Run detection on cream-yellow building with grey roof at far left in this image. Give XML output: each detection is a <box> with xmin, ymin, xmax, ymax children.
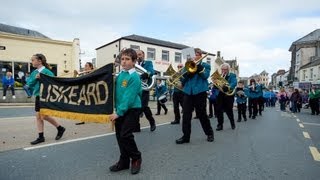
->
<box><xmin>0</xmin><ymin>24</ymin><xmax>80</xmax><ymax>85</ymax></box>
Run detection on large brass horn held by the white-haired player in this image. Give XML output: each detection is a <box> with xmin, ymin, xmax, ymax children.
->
<box><xmin>210</xmin><ymin>70</ymin><xmax>236</xmax><ymax>96</ymax></box>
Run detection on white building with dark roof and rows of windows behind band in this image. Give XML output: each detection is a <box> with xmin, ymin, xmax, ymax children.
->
<box><xmin>96</xmin><ymin>35</ymin><xmax>215</xmax><ymax>75</ymax></box>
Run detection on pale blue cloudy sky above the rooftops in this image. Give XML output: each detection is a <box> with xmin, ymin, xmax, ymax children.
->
<box><xmin>0</xmin><ymin>0</ymin><xmax>320</xmax><ymax>76</ymax></box>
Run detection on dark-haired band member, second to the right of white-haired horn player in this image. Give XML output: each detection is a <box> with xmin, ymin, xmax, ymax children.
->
<box><xmin>248</xmin><ymin>79</ymin><xmax>259</xmax><ymax>119</ymax></box>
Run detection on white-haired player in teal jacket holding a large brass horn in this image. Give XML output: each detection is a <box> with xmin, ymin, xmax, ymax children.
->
<box><xmin>214</xmin><ymin>63</ymin><xmax>237</xmax><ymax>131</ymax></box>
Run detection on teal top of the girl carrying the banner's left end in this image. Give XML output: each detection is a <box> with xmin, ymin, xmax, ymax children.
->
<box><xmin>27</xmin><ymin>68</ymin><xmax>54</xmax><ymax>96</ymax></box>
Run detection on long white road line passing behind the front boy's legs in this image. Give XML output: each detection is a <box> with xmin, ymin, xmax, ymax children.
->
<box><xmin>23</xmin><ymin>122</ymin><xmax>170</xmax><ymax>151</ymax></box>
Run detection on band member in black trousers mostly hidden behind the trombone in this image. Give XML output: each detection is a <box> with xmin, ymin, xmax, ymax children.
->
<box><xmin>171</xmin><ymin>64</ymin><xmax>183</xmax><ymax>124</ymax></box>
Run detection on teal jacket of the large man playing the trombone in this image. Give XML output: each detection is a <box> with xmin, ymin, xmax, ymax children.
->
<box><xmin>182</xmin><ymin>62</ymin><xmax>211</xmax><ymax>95</ymax></box>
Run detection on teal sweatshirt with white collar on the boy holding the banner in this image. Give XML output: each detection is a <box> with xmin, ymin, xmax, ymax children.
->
<box><xmin>115</xmin><ymin>69</ymin><xmax>142</xmax><ymax>116</ymax></box>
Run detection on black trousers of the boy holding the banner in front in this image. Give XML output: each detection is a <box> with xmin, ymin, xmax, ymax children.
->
<box><xmin>115</xmin><ymin>108</ymin><xmax>141</xmax><ymax>165</ymax></box>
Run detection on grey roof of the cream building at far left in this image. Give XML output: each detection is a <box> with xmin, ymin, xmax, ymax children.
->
<box><xmin>0</xmin><ymin>23</ymin><xmax>50</xmax><ymax>39</ymax></box>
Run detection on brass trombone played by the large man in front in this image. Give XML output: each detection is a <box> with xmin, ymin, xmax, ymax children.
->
<box><xmin>168</xmin><ymin>53</ymin><xmax>209</xmax><ymax>87</ymax></box>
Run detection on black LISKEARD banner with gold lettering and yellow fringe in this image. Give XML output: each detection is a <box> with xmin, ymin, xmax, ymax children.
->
<box><xmin>40</xmin><ymin>64</ymin><xmax>114</xmax><ymax>123</ymax></box>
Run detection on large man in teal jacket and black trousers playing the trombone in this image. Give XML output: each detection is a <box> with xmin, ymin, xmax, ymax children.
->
<box><xmin>176</xmin><ymin>48</ymin><xmax>214</xmax><ymax>144</ymax></box>
